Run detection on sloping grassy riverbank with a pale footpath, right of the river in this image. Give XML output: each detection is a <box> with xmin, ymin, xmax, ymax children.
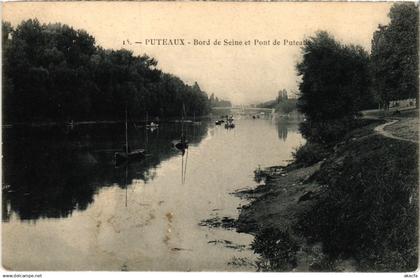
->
<box><xmin>236</xmin><ymin>112</ymin><xmax>418</xmax><ymax>271</ymax></box>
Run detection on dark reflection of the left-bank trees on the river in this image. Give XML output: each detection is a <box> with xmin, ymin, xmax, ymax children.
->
<box><xmin>3</xmin><ymin>121</ymin><xmax>207</xmax><ymax>220</ymax></box>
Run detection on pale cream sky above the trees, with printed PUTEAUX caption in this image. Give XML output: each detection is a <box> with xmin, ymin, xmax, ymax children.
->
<box><xmin>2</xmin><ymin>1</ymin><xmax>392</xmax><ymax>104</ymax></box>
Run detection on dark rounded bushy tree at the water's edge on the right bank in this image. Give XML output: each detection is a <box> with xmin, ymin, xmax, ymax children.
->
<box><xmin>297</xmin><ymin>31</ymin><xmax>370</xmax><ymax>141</ymax></box>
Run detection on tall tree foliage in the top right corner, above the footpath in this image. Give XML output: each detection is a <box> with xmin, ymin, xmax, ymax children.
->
<box><xmin>371</xmin><ymin>2</ymin><xmax>419</xmax><ymax>107</ymax></box>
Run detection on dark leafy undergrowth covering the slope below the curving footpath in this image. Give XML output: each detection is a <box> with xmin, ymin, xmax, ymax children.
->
<box><xmin>299</xmin><ymin>136</ymin><xmax>418</xmax><ymax>271</ymax></box>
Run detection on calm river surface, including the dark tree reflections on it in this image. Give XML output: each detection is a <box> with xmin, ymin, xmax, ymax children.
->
<box><xmin>2</xmin><ymin>119</ymin><xmax>303</xmax><ymax>271</ymax></box>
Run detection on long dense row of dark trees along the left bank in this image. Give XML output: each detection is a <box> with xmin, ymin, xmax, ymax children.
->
<box><xmin>2</xmin><ymin>19</ymin><xmax>230</xmax><ymax>122</ymax></box>
